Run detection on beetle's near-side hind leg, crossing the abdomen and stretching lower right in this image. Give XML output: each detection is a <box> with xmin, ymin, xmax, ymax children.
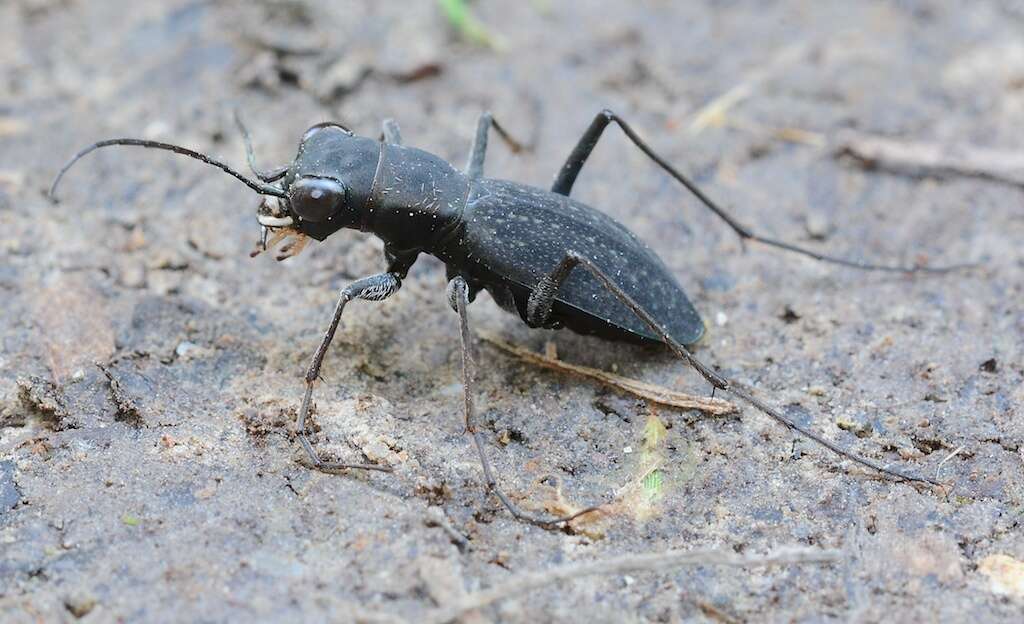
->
<box><xmin>526</xmin><ymin>251</ymin><xmax>942</xmax><ymax>486</ymax></box>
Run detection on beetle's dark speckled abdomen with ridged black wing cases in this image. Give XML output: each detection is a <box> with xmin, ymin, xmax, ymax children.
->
<box><xmin>439</xmin><ymin>179</ymin><xmax>705</xmax><ymax>344</ymax></box>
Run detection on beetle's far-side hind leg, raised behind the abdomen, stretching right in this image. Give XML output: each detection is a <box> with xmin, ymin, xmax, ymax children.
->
<box><xmin>551</xmin><ymin>109</ymin><xmax>976</xmax><ymax>273</ymax></box>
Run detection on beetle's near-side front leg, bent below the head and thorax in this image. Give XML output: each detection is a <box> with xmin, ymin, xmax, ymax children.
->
<box><xmin>295</xmin><ymin>273</ymin><xmax>401</xmax><ymax>472</ymax></box>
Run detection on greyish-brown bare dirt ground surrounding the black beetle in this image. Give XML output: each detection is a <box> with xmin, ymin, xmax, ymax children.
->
<box><xmin>0</xmin><ymin>0</ymin><xmax>1024</xmax><ymax>622</ymax></box>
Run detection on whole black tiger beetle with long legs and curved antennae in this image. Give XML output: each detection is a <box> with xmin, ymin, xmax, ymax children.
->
<box><xmin>50</xmin><ymin>110</ymin><xmax>962</xmax><ymax>528</ymax></box>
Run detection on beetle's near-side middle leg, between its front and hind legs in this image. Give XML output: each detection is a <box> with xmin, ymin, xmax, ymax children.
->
<box><xmin>447</xmin><ymin>276</ymin><xmax>600</xmax><ymax>529</ymax></box>
